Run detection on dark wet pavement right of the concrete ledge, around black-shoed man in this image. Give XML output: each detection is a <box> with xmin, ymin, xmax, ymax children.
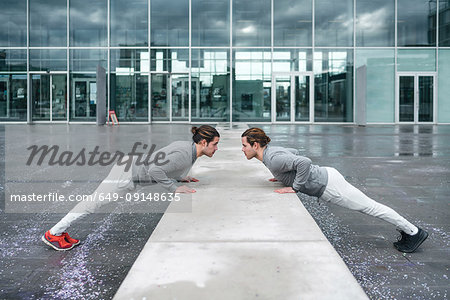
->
<box><xmin>256</xmin><ymin>125</ymin><xmax>450</xmax><ymax>300</ymax></box>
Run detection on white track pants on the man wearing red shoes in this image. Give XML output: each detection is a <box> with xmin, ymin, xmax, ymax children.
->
<box><xmin>50</xmin><ymin>158</ymin><xmax>135</xmax><ymax>235</ymax></box>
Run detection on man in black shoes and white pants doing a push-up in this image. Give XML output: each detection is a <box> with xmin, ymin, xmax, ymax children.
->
<box><xmin>241</xmin><ymin>128</ymin><xmax>428</xmax><ymax>253</ymax></box>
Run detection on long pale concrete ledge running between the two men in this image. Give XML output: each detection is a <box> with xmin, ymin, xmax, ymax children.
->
<box><xmin>114</xmin><ymin>129</ymin><xmax>367</xmax><ymax>300</ymax></box>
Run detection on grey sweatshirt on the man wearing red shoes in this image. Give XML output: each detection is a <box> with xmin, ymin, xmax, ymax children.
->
<box><xmin>132</xmin><ymin>141</ymin><xmax>197</xmax><ymax>193</ymax></box>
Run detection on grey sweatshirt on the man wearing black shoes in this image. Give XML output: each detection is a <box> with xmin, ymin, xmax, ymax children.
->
<box><xmin>263</xmin><ymin>145</ymin><xmax>328</xmax><ymax>198</ymax></box>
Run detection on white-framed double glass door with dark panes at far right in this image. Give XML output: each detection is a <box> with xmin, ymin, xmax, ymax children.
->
<box><xmin>397</xmin><ymin>73</ymin><xmax>435</xmax><ymax>124</ymax></box>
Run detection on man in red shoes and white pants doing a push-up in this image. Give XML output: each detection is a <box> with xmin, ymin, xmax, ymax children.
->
<box><xmin>42</xmin><ymin>125</ymin><xmax>220</xmax><ymax>251</ymax></box>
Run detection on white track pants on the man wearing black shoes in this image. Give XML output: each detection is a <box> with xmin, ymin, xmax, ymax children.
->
<box><xmin>319</xmin><ymin>167</ymin><xmax>417</xmax><ymax>234</ymax></box>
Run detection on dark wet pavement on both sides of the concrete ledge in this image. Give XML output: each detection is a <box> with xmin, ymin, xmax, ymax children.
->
<box><xmin>0</xmin><ymin>125</ymin><xmax>450</xmax><ymax>299</ymax></box>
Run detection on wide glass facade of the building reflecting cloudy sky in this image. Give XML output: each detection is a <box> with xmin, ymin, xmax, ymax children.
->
<box><xmin>0</xmin><ymin>0</ymin><xmax>450</xmax><ymax>124</ymax></box>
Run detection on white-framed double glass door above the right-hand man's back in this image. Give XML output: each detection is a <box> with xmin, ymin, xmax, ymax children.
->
<box><xmin>272</xmin><ymin>73</ymin><xmax>313</xmax><ymax>122</ymax></box>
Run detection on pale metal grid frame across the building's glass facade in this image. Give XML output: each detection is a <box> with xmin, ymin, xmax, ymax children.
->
<box><xmin>0</xmin><ymin>0</ymin><xmax>444</xmax><ymax>126</ymax></box>
